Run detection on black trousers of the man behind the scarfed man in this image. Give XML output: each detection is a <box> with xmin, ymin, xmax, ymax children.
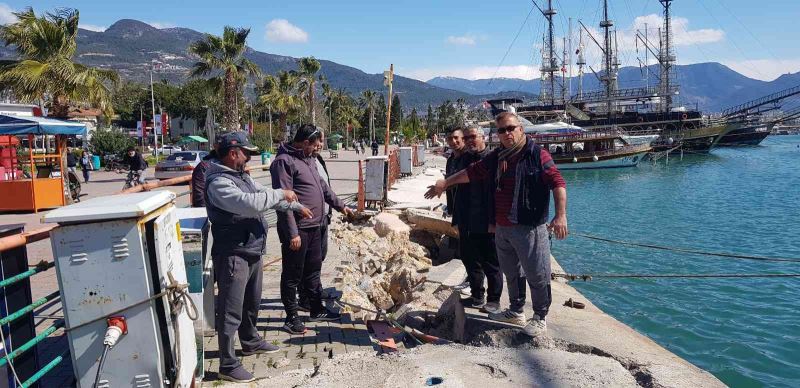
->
<box><xmin>458</xmin><ymin>228</ymin><xmax>503</xmax><ymax>303</ymax></box>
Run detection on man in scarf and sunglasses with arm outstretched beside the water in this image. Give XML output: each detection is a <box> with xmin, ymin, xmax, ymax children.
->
<box><xmin>425</xmin><ymin>112</ymin><xmax>568</xmax><ymax>336</ymax></box>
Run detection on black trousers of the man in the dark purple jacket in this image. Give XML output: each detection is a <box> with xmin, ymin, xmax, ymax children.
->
<box><xmin>281</xmin><ymin>227</ymin><xmax>323</xmax><ymax>317</ymax></box>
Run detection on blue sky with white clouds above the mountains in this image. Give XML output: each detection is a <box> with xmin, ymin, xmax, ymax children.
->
<box><xmin>0</xmin><ymin>0</ymin><xmax>800</xmax><ymax>81</ymax></box>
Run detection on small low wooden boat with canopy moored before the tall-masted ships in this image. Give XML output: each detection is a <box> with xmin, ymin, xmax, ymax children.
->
<box><xmin>529</xmin><ymin>132</ymin><xmax>652</xmax><ymax>170</ymax></box>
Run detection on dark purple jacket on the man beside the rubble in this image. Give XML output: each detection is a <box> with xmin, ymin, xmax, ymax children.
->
<box><xmin>269</xmin><ymin>144</ymin><xmax>345</xmax><ymax>243</ymax></box>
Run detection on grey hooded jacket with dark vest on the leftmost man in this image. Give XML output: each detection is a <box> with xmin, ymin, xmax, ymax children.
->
<box><xmin>205</xmin><ymin>162</ymin><xmax>304</xmax><ymax>260</ymax></box>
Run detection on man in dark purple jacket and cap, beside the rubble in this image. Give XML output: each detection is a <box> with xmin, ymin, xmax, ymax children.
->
<box><xmin>270</xmin><ymin>124</ymin><xmax>352</xmax><ymax>334</ymax></box>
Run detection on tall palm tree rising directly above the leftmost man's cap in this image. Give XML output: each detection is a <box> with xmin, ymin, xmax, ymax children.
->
<box><xmin>189</xmin><ymin>26</ymin><xmax>261</xmax><ymax>131</ymax></box>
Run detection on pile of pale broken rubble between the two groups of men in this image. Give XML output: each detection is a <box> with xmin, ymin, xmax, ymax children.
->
<box><xmin>331</xmin><ymin>212</ymin><xmax>432</xmax><ymax>320</ymax></box>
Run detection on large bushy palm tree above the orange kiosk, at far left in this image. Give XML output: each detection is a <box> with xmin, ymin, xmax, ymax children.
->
<box><xmin>0</xmin><ymin>7</ymin><xmax>119</xmax><ymax>118</ymax></box>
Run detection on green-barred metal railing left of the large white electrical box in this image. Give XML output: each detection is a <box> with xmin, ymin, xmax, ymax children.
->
<box><xmin>0</xmin><ymin>226</ymin><xmax>69</xmax><ymax>387</ymax></box>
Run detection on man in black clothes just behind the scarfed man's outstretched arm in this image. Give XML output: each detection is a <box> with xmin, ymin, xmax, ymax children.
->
<box><xmin>453</xmin><ymin>126</ymin><xmax>503</xmax><ymax>313</ymax></box>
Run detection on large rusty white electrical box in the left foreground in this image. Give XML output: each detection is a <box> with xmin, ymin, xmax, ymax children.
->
<box><xmin>44</xmin><ymin>191</ymin><xmax>197</xmax><ymax>388</ymax></box>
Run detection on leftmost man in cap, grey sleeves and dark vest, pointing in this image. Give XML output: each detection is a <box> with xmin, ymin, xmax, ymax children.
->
<box><xmin>205</xmin><ymin>132</ymin><xmax>312</xmax><ymax>382</ymax></box>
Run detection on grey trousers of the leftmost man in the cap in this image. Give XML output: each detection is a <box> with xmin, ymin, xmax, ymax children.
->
<box><xmin>212</xmin><ymin>256</ymin><xmax>264</xmax><ymax>372</ymax></box>
